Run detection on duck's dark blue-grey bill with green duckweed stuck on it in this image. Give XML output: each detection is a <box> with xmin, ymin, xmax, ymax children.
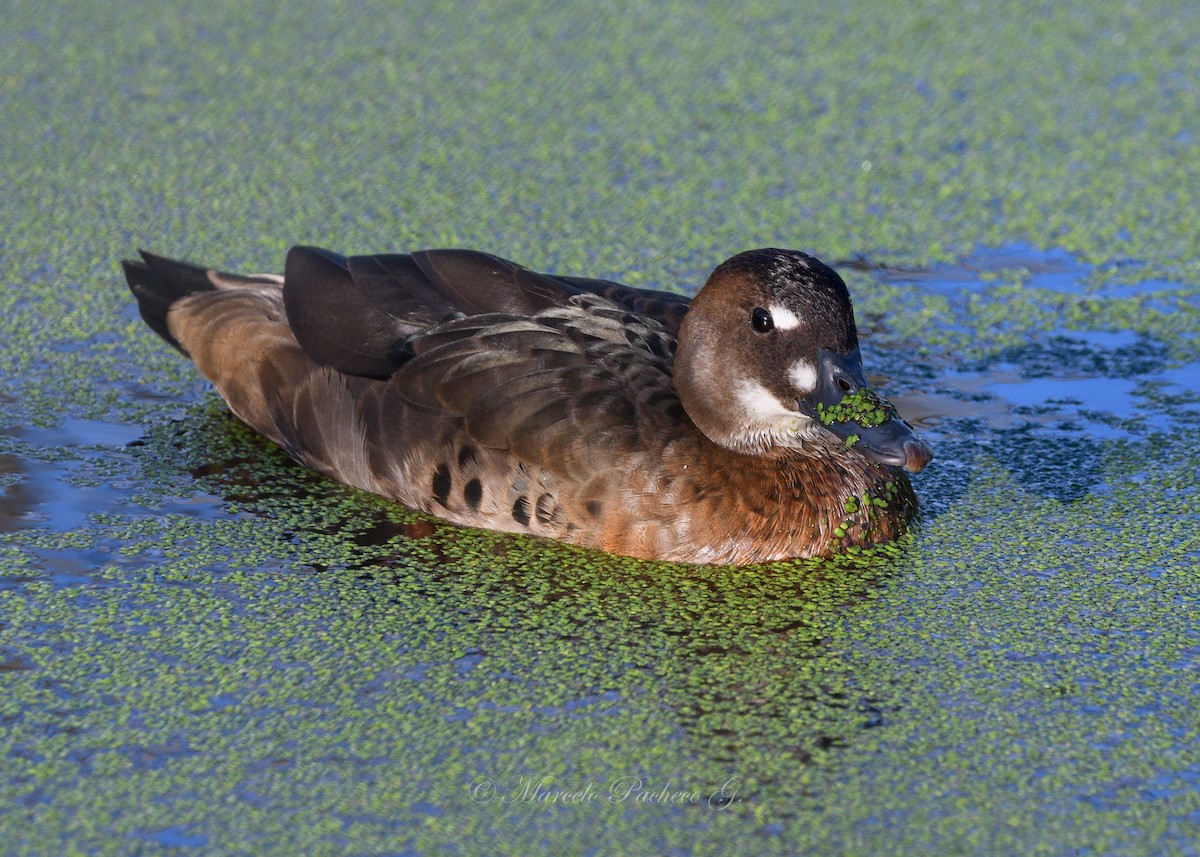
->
<box><xmin>799</xmin><ymin>349</ymin><xmax>934</xmax><ymax>473</ymax></box>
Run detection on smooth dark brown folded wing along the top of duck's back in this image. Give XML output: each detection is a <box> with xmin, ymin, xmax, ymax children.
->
<box><xmin>283</xmin><ymin>247</ymin><xmax>688</xmax><ymax>378</ymax></box>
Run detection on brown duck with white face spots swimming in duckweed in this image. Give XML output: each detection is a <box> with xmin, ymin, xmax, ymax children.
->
<box><xmin>122</xmin><ymin>246</ymin><xmax>932</xmax><ymax>565</ymax></box>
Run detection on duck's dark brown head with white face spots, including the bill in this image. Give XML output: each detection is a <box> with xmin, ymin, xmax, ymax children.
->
<box><xmin>674</xmin><ymin>250</ymin><xmax>934</xmax><ymax>473</ymax></box>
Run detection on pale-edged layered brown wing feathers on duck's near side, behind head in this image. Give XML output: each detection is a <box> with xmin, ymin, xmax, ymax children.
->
<box><xmin>390</xmin><ymin>294</ymin><xmax>683</xmax><ymax>469</ymax></box>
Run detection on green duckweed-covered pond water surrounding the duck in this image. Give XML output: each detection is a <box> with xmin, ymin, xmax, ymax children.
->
<box><xmin>0</xmin><ymin>0</ymin><xmax>1200</xmax><ymax>857</ymax></box>
